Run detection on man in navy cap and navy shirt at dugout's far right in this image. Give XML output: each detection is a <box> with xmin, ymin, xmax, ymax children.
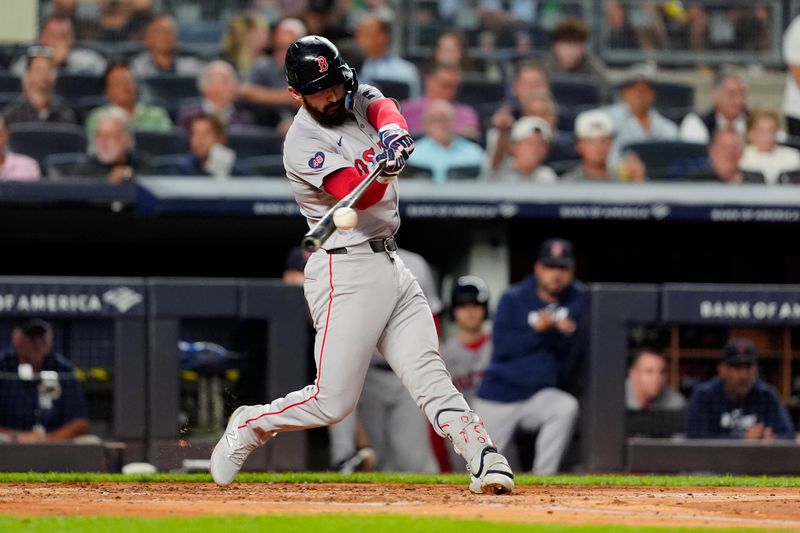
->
<box><xmin>686</xmin><ymin>338</ymin><xmax>795</xmax><ymax>441</ymax></box>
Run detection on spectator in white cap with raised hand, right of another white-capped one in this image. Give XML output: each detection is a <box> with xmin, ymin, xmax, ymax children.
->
<box><xmin>561</xmin><ymin>109</ymin><xmax>645</xmax><ymax>181</ymax></box>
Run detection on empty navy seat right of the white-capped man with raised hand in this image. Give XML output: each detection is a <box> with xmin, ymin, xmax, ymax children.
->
<box><xmin>623</xmin><ymin>141</ymin><xmax>708</xmax><ymax>181</ymax></box>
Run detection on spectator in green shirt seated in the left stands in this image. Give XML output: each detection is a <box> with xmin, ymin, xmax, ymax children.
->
<box><xmin>86</xmin><ymin>63</ymin><xmax>172</xmax><ymax>144</ymax></box>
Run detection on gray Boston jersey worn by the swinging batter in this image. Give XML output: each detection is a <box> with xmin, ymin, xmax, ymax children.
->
<box><xmin>283</xmin><ymin>85</ymin><xmax>400</xmax><ymax>249</ymax></box>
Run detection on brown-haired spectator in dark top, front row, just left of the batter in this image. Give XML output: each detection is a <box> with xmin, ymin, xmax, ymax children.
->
<box><xmin>174</xmin><ymin>113</ymin><xmax>248</xmax><ymax>178</ymax></box>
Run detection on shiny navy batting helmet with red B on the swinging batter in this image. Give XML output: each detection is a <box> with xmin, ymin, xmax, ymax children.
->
<box><xmin>284</xmin><ymin>35</ymin><xmax>358</xmax><ymax>95</ymax></box>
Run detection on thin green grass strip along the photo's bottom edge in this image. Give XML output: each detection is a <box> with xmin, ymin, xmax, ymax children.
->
<box><xmin>0</xmin><ymin>515</ymin><xmax>788</xmax><ymax>533</ymax></box>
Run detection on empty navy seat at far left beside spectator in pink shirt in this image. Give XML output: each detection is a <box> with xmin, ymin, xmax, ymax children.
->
<box><xmin>8</xmin><ymin>122</ymin><xmax>86</xmax><ymax>168</ymax></box>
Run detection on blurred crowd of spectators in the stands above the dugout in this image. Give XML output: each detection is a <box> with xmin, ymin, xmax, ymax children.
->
<box><xmin>0</xmin><ymin>0</ymin><xmax>800</xmax><ymax>185</ymax></box>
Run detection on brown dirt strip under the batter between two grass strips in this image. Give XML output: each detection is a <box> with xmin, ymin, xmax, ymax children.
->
<box><xmin>0</xmin><ymin>483</ymin><xmax>800</xmax><ymax>530</ymax></box>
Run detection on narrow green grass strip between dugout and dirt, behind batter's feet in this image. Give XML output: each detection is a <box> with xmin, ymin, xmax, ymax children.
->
<box><xmin>0</xmin><ymin>472</ymin><xmax>800</xmax><ymax>488</ymax></box>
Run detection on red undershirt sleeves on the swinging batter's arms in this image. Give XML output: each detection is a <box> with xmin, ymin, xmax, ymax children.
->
<box><xmin>322</xmin><ymin>98</ymin><xmax>408</xmax><ymax>209</ymax></box>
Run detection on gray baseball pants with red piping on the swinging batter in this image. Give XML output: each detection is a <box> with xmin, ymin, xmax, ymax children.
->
<box><xmin>238</xmin><ymin>243</ymin><xmax>469</xmax><ymax>440</ymax></box>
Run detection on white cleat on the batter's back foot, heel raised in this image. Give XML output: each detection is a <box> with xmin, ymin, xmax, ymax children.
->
<box><xmin>208</xmin><ymin>405</ymin><xmax>274</xmax><ymax>485</ymax></box>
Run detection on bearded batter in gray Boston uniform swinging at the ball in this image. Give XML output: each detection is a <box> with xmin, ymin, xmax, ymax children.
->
<box><xmin>210</xmin><ymin>35</ymin><xmax>514</xmax><ymax>494</ymax></box>
